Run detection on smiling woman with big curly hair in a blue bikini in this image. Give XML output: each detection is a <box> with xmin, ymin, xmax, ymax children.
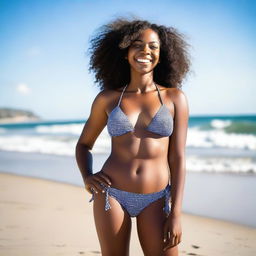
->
<box><xmin>76</xmin><ymin>19</ymin><xmax>189</xmax><ymax>256</ymax></box>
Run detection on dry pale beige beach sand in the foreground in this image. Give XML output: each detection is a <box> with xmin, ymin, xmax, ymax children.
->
<box><xmin>0</xmin><ymin>174</ymin><xmax>256</xmax><ymax>256</ymax></box>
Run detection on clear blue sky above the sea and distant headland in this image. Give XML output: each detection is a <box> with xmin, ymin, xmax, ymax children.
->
<box><xmin>0</xmin><ymin>0</ymin><xmax>256</xmax><ymax>119</ymax></box>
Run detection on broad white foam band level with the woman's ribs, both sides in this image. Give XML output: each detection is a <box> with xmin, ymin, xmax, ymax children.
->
<box><xmin>0</xmin><ymin>127</ymin><xmax>256</xmax><ymax>155</ymax></box>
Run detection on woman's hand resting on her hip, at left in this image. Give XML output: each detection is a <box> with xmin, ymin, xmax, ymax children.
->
<box><xmin>85</xmin><ymin>171</ymin><xmax>111</xmax><ymax>194</ymax></box>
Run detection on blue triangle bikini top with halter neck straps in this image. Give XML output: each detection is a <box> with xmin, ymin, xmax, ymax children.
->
<box><xmin>107</xmin><ymin>84</ymin><xmax>173</xmax><ymax>137</ymax></box>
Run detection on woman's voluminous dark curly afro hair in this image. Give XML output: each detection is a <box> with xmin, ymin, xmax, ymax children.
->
<box><xmin>89</xmin><ymin>18</ymin><xmax>190</xmax><ymax>90</ymax></box>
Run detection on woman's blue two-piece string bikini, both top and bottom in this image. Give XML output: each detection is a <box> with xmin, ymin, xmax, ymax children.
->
<box><xmin>89</xmin><ymin>84</ymin><xmax>173</xmax><ymax>217</ymax></box>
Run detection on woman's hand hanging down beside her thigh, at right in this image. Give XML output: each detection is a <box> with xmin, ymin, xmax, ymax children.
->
<box><xmin>164</xmin><ymin>214</ymin><xmax>182</xmax><ymax>251</ymax></box>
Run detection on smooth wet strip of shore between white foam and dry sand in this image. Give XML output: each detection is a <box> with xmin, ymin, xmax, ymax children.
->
<box><xmin>0</xmin><ymin>151</ymin><xmax>256</xmax><ymax>228</ymax></box>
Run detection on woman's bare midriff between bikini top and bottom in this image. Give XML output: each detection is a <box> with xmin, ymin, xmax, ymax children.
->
<box><xmin>99</xmin><ymin>134</ymin><xmax>169</xmax><ymax>194</ymax></box>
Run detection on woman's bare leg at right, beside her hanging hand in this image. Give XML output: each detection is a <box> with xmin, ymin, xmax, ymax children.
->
<box><xmin>137</xmin><ymin>197</ymin><xmax>178</xmax><ymax>256</ymax></box>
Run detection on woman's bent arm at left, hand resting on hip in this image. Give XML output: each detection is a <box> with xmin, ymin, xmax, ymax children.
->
<box><xmin>76</xmin><ymin>91</ymin><xmax>111</xmax><ymax>193</ymax></box>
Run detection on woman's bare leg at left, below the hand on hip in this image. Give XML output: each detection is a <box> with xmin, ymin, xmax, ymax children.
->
<box><xmin>93</xmin><ymin>193</ymin><xmax>131</xmax><ymax>256</ymax></box>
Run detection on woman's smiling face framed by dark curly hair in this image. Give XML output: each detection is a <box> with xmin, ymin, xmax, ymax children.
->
<box><xmin>127</xmin><ymin>29</ymin><xmax>160</xmax><ymax>74</ymax></box>
